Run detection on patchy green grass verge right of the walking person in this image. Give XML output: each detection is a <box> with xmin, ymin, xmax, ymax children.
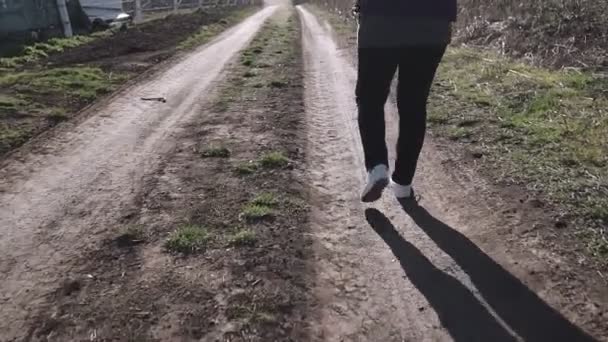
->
<box><xmin>429</xmin><ymin>48</ymin><xmax>608</xmax><ymax>257</ymax></box>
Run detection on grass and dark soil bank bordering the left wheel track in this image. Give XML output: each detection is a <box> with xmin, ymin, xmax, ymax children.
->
<box><xmin>0</xmin><ymin>7</ymin><xmax>254</xmax><ymax>155</ymax></box>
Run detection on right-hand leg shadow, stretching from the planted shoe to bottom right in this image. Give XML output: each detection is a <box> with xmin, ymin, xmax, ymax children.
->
<box><xmin>402</xmin><ymin>202</ymin><xmax>596</xmax><ymax>342</ymax></box>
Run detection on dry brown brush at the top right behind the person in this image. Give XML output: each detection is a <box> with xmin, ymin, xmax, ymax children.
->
<box><xmin>307</xmin><ymin>0</ymin><xmax>608</xmax><ymax>70</ymax></box>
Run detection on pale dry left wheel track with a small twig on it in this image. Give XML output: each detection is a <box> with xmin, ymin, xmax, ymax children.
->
<box><xmin>0</xmin><ymin>6</ymin><xmax>276</xmax><ymax>340</ymax></box>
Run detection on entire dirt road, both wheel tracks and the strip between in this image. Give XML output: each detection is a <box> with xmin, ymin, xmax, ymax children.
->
<box><xmin>0</xmin><ymin>2</ymin><xmax>608</xmax><ymax>342</ymax></box>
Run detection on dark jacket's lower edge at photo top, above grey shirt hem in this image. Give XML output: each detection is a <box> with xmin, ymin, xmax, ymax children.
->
<box><xmin>357</xmin><ymin>0</ymin><xmax>457</xmax><ymax>21</ymax></box>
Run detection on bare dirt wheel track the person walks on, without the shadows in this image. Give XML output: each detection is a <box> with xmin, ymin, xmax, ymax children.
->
<box><xmin>298</xmin><ymin>7</ymin><xmax>593</xmax><ymax>342</ymax></box>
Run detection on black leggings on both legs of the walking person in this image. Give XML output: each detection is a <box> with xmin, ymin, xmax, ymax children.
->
<box><xmin>356</xmin><ymin>46</ymin><xmax>446</xmax><ymax>185</ymax></box>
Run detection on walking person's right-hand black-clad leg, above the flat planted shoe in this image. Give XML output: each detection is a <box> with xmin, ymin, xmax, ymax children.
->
<box><xmin>393</xmin><ymin>46</ymin><xmax>446</xmax><ymax>188</ymax></box>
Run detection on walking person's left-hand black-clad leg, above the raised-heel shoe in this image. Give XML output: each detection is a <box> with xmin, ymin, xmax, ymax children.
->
<box><xmin>356</xmin><ymin>48</ymin><xmax>398</xmax><ymax>171</ymax></box>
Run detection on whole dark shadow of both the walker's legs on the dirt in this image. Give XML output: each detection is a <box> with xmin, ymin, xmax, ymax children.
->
<box><xmin>365</xmin><ymin>203</ymin><xmax>595</xmax><ymax>342</ymax></box>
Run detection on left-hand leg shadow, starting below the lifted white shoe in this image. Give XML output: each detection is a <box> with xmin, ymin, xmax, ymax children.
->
<box><xmin>365</xmin><ymin>209</ymin><xmax>516</xmax><ymax>342</ymax></box>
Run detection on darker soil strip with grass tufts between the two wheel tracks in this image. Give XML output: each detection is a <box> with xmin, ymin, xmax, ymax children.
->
<box><xmin>20</xmin><ymin>7</ymin><xmax>309</xmax><ymax>341</ymax></box>
